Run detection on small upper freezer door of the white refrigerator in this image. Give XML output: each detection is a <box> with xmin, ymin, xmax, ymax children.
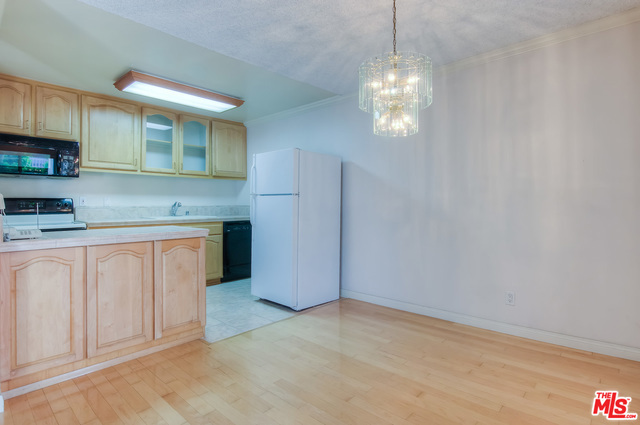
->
<box><xmin>251</xmin><ymin>149</ymin><xmax>300</xmax><ymax>195</ymax></box>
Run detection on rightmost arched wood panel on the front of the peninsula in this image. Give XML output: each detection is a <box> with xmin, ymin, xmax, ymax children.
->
<box><xmin>154</xmin><ymin>238</ymin><xmax>206</xmax><ymax>338</ymax></box>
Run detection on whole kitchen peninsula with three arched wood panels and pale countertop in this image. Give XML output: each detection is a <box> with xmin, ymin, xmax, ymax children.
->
<box><xmin>0</xmin><ymin>226</ymin><xmax>209</xmax><ymax>399</ymax></box>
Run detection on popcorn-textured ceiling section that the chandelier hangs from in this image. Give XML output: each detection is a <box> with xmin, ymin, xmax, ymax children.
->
<box><xmin>80</xmin><ymin>0</ymin><xmax>640</xmax><ymax>94</ymax></box>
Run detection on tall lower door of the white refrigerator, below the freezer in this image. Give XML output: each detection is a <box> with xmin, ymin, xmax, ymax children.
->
<box><xmin>251</xmin><ymin>195</ymin><xmax>298</xmax><ymax>310</ymax></box>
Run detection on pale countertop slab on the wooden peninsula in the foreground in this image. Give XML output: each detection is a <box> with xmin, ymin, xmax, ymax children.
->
<box><xmin>0</xmin><ymin>226</ymin><xmax>209</xmax><ymax>253</ymax></box>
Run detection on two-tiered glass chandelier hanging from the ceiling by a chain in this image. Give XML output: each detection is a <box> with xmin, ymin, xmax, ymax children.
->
<box><xmin>359</xmin><ymin>0</ymin><xmax>431</xmax><ymax>137</ymax></box>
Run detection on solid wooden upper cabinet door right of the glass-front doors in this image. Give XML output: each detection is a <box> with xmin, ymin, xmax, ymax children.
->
<box><xmin>212</xmin><ymin>122</ymin><xmax>247</xmax><ymax>179</ymax></box>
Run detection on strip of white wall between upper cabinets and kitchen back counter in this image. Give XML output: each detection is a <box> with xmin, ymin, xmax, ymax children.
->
<box><xmin>0</xmin><ymin>171</ymin><xmax>249</xmax><ymax>207</ymax></box>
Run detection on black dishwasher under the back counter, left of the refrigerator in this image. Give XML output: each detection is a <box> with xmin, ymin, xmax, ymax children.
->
<box><xmin>220</xmin><ymin>220</ymin><xmax>251</xmax><ymax>282</ymax></box>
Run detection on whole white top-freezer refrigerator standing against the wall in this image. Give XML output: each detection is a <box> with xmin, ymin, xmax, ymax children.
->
<box><xmin>250</xmin><ymin>149</ymin><xmax>342</xmax><ymax>310</ymax></box>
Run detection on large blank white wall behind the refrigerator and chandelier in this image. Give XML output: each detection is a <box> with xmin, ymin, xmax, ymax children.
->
<box><xmin>242</xmin><ymin>16</ymin><xmax>640</xmax><ymax>360</ymax></box>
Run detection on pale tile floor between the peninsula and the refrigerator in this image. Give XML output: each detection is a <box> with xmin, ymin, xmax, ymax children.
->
<box><xmin>204</xmin><ymin>279</ymin><xmax>296</xmax><ymax>342</ymax></box>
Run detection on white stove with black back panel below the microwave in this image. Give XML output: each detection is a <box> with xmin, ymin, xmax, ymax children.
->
<box><xmin>3</xmin><ymin>198</ymin><xmax>87</xmax><ymax>232</ymax></box>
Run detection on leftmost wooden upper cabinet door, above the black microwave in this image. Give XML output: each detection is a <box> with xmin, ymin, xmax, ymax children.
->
<box><xmin>0</xmin><ymin>78</ymin><xmax>31</xmax><ymax>135</ymax></box>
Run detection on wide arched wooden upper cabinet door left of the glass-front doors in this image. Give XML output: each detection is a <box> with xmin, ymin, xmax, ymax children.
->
<box><xmin>80</xmin><ymin>95</ymin><xmax>140</xmax><ymax>171</ymax></box>
